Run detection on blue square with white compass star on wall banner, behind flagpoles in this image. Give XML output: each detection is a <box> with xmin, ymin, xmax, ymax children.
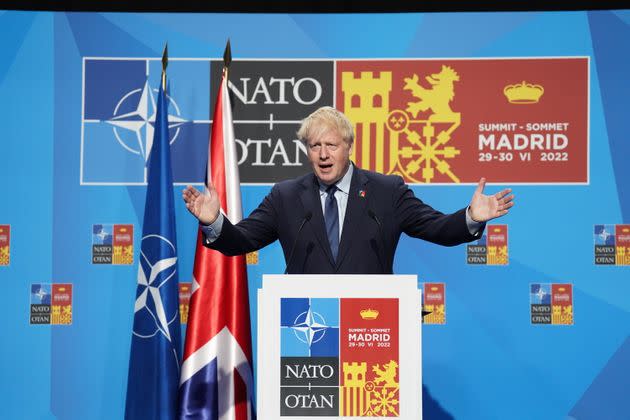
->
<box><xmin>81</xmin><ymin>58</ymin><xmax>210</xmax><ymax>185</ymax></box>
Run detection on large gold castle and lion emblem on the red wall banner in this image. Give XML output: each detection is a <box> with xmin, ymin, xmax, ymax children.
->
<box><xmin>341</xmin><ymin>65</ymin><xmax>461</xmax><ymax>183</ymax></box>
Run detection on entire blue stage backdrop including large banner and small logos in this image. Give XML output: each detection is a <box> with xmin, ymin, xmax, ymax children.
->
<box><xmin>0</xmin><ymin>11</ymin><xmax>630</xmax><ymax>420</ymax></box>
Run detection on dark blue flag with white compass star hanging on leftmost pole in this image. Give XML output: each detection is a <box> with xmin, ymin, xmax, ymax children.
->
<box><xmin>125</xmin><ymin>81</ymin><xmax>181</xmax><ymax>420</ymax></box>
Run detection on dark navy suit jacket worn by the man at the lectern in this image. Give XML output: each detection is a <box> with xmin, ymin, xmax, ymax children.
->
<box><xmin>204</xmin><ymin>166</ymin><xmax>483</xmax><ymax>274</ymax></box>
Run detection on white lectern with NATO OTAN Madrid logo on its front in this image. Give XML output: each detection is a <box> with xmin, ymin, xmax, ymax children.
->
<box><xmin>257</xmin><ymin>275</ymin><xmax>422</xmax><ymax>420</ymax></box>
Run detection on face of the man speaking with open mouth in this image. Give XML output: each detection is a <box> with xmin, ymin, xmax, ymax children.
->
<box><xmin>306</xmin><ymin>130</ymin><xmax>352</xmax><ymax>185</ymax></box>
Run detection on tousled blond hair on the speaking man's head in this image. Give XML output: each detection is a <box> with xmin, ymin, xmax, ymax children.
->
<box><xmin>297</xmin><ymin>106</ymin><xmax>354</xmax><ymax>144</ymax></box>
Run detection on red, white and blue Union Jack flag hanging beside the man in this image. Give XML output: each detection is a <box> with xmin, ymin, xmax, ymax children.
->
<box><xmin>179</xmin><ymin>60</ymin><xmax>255</xmax><ymax>420</ymax></box>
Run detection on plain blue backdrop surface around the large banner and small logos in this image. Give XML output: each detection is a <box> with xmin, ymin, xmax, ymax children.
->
<box><xmin>0</xmin><ymin>11</ymin><xmax>630</xmax><ymax>420</ymax></box>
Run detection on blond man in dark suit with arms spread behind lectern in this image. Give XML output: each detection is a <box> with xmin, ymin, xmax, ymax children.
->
<box><xmin>182</xmin><ymin>107</ymin><xmax>514</xmax><ymax>274</ymax></box>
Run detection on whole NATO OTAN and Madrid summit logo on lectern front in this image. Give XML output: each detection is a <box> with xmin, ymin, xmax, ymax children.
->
<box><xmin>280</xmin><ymin>298</ymin><xmax>400</xmax><ymax>417</ymax></box>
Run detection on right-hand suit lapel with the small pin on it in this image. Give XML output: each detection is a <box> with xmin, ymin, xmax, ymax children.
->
<box><xmin>337</xmin><ymin>166</ymin><xmax>370</xmax><ymax>267</ymax></box>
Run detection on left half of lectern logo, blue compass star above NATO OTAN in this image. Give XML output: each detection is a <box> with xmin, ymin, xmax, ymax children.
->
<box><xmin>280</xmin><ymin>298</ymin><xmax>339</xmax><ymax>416</ymax></box>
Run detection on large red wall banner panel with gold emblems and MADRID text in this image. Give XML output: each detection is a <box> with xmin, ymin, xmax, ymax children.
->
<box><xmin>336</xmin><ymin>57</ymin><xmax>589</xmax><ymax>184</ymax></box>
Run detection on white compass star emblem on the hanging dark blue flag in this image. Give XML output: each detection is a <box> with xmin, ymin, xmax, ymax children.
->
<box><xmin>133</xmin><ymin>235</ymin><xmax>179</xmax><ymax>341</ymax></box>
